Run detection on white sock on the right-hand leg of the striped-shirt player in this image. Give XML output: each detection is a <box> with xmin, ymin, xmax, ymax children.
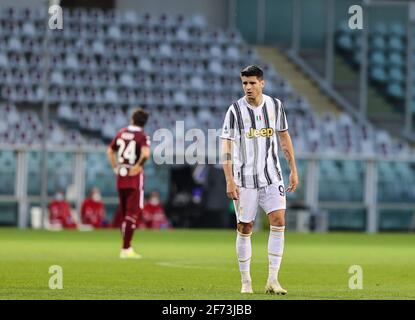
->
<box><xmin>268</xmin><ymin>226</ymin><xmax>285</xmax><ymax>282</ymax></box>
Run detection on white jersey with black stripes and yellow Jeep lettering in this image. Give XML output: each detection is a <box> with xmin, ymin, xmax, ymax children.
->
<box><xmin>221</xmin><ymin>94</ymin><xmax>288</xmax><ymax>188</ymax></box>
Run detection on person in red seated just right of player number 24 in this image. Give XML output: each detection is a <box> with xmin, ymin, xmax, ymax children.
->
<box><xmin>140</xmin><ymin>191</ymin><xmax>171</xmax><ymax>229</ymax></box>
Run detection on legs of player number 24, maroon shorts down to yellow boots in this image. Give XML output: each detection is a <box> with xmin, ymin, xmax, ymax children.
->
<box><xmin>120</xmin><ymin>189</ymin><xmax>141</xmax><ymax>258</ymax></box>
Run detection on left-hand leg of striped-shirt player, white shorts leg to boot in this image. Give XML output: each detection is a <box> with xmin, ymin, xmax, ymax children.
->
<box><xmin>234</xmin><ymin>188</ymin><xmax>258</xmax><ymax>293</ymax></box>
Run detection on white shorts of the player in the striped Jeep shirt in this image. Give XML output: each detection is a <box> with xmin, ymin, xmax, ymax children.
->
<box><xmin>233</xmin><ymin>181</ymin><xmax>286</xmax><ymax>223</ymax></box>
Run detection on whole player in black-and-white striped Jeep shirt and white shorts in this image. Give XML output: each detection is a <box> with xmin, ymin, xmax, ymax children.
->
<box><xmin>221</xmin><ymin>66</ymin><xmax>298</xmax><ymax>294</ymax></box>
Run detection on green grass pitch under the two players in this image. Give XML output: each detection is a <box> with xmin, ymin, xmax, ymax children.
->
<box><xmin>0</xmin><ymin>229</ymin><xmax>415</xmax><ymax>300</ymax></box>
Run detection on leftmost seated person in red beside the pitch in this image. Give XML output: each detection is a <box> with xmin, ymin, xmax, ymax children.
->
<box><xmin>48</xmin><ymin>190</ymin><xmax>78</xmax><ymax>229</ymax></box>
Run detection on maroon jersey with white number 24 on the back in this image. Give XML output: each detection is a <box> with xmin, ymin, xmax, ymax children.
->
<box><xmin>110</xmin><ymin>125</ymin><xmax>150</xmax><ymax>189</ymax></box>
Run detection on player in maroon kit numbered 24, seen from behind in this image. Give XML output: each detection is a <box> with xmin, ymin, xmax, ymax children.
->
<box><xmin>107</xmin><ymin>108</ymin><xmax>150</xmax><ymax>259</ymax></box>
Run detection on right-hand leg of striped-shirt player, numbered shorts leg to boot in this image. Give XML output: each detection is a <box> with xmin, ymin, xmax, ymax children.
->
<box><xmin>259</xmin><ymin>184</ymin><xmax>287</xmax><ymax>294</ymax></box>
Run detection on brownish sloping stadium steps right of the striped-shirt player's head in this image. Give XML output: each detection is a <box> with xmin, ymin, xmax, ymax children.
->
<box><xmin>256</xmin><ymin>46</ymin><xmax>341</xmax><ymax>115</ymax></box>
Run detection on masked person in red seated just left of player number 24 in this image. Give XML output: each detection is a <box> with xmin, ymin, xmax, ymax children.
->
<box><xmin>81</xmin><ymin>187</ymin><xmax>107</xmax><ymax>228</ymax></box>
